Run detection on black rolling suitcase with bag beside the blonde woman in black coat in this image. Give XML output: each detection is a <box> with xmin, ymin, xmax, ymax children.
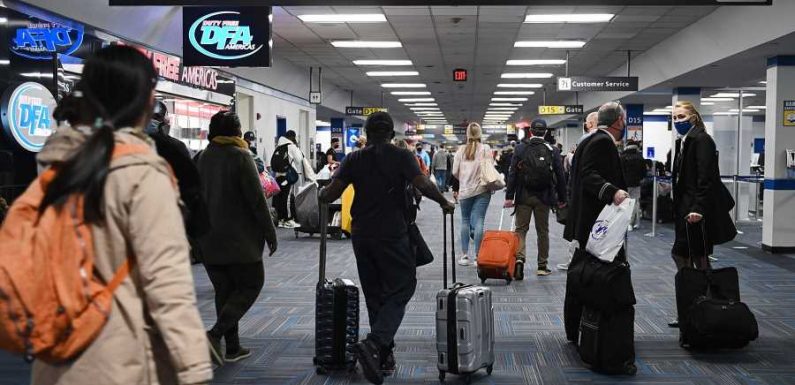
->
<box><xmin>675</xmin><ymin>221</ymin><xmax>759</xmax><ymax>349</ymax></box>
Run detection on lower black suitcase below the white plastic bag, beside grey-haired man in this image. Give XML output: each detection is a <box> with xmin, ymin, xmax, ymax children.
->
<box><xmin>579</xmin><ymin>306</ymin><xmax>638</xmax><ymax>375</ymax></box>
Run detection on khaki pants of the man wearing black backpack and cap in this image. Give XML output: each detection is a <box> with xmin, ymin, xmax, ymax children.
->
<box><xmin>516</xmin><ymin>196</ymin><xmax>549</xmax><ymax>270</ymax></box>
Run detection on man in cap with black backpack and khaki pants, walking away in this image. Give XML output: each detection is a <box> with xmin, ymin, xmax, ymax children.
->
<box><xmin>505</xmin><ymin>119</ymin><xmax>566</xmax><ymax>280</ymax></box>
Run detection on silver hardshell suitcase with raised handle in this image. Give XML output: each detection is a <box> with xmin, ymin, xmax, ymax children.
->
<box><xmin>436</xmin><ymin>215</ymin><xmax>494</xmax><ymax>383</ymax></box>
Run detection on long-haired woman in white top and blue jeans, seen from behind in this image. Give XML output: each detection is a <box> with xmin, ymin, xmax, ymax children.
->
<box><xmin>453</xmin><ymin>123</ymin><xmax>492</xmax><ymax>266</ymax></box>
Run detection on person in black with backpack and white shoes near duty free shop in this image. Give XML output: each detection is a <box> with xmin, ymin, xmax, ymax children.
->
<box><xmin>271</xmin><ymin>130</ymin><xmax>304</xmax><ymax>229</ymax></box>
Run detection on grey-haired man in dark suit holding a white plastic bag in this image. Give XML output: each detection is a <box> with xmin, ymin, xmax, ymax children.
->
<box><xmin>563</xmin><ymin>102</ymin><xmax>629</xmax><ymax>249</ymax></box>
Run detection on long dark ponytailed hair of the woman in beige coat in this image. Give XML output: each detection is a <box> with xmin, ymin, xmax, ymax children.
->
<box><xmin>39</xmin><ymin>46</ymin><xmax>157</xmax><ymax>223</ymax></box>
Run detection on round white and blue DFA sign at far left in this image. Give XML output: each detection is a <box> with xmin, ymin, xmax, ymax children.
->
<box><xmin>3</xmin><ymin>82</ymin><xmax>56</xmax><ymax>152</ymax></box>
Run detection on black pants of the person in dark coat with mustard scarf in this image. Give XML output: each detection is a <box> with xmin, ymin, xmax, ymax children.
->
<box><xmin>204</xmin><ymin>261</ymin><xmax>265</xmax><ymax>352</ymax></box>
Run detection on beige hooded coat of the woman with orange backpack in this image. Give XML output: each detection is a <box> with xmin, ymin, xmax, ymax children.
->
<box><xmin>31</xmin><ymin>128</ymin><xmax>212</xmax><ymax>385</ymax></box>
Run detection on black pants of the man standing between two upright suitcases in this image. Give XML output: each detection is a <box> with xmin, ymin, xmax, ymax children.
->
<box><xmin>352</xmin><ymin>234</ymin><xmax>417</xmax><ymax>349</ymax></box>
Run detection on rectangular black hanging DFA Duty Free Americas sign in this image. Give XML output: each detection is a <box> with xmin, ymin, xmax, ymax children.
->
<box><xmin>182</xmin><ymin>7</ymin><xmax>273</xmax><ymax>67</ymax></box>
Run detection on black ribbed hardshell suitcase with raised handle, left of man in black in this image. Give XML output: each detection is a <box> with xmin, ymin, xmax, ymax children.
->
<box><xmin>314</xmin><ymin>204</ymin><xmax>359</xmax><ymax>374</ymax></box>
